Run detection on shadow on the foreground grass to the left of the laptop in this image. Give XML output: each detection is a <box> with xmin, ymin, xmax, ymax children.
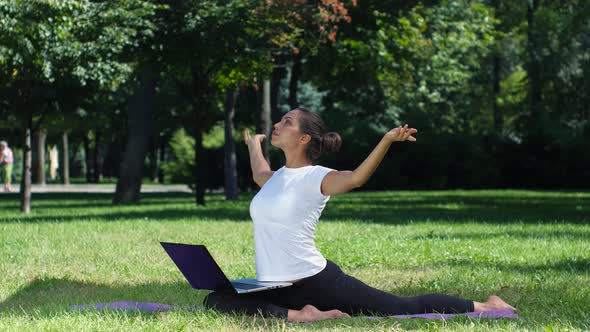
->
<box><xmin>0</xmin><ymin>278</ymin><xmax>209</xmax><ymax>317</ymax></box>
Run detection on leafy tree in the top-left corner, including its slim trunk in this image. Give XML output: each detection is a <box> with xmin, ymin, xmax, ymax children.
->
<box><xmin>0</xmin><ymin>0</ymin><xmax>154</xmax><ymax>213</ymax></box>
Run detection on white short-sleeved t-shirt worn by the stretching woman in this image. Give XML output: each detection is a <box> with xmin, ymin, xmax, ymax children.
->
<box><xmin>250</xmin><ymin>165</ymin><xmax>333</xmax><ymax>281</ymax></box>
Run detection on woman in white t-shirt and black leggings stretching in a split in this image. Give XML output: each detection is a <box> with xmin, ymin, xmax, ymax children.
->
<box><xmin>205</xmin><ymin>108</ymin><xmax>514</xmax><ymax>321</ymax></box>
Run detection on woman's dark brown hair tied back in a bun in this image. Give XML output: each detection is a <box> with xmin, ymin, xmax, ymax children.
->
<box><xmin>294</xmin><ymin>108</ymin><xmax>342</xmax><ymax>161</ymax></box>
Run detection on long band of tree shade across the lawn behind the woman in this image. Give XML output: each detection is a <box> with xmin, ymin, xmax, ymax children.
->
<box><xmin>0</xmin><ymin>191</ymin><xmax>590</xmax><ymax>224</ymax></box>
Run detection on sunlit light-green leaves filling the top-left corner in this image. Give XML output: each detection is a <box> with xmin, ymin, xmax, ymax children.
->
<box><xmin>0</xmin><ymin>0</ymin><xmax>156</xmax><ymax>89</ymax></box>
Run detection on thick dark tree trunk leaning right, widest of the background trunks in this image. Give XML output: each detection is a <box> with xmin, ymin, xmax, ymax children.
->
<box><xmin>113</xmin><ymin>69</ymin><xmax>156</xmax><ymax>204</ymax></box>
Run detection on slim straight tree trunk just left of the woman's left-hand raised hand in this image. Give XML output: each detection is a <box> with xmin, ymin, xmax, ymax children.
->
<box><xmin>223</xmin><ymin>87</ymin><xmax>238</xmax><ymax>200</ymax></box>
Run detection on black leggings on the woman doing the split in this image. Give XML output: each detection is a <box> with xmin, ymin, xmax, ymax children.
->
<box><xmin>204</xmin><ymin>260</ymin><xmax>474</xmax><ymax>318</ymax></box>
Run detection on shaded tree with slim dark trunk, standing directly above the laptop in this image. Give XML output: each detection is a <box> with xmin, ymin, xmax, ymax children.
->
<box><xmin>156</xmin><ymin>0</ymin><xmax>274</xmax><ymax>205</ymax></box>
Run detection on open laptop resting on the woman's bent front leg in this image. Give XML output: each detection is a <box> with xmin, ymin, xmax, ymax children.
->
<box><xmin>160</xmin><ymin>242</ymin><xmax>292</xmax><ymax>294</ymax></box>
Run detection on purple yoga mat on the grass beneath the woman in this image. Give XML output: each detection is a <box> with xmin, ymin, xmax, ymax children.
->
<box><xmin>70</xmin><ymin>301</ymin><xmax>518</xmax><ymax>319</ymax></box>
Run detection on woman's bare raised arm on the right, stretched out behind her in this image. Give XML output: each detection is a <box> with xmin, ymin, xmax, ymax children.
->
<box><xmin>322</xmin><ymin>125</ymin><xmax>418</xmax><ymax>196</ymax></box>
